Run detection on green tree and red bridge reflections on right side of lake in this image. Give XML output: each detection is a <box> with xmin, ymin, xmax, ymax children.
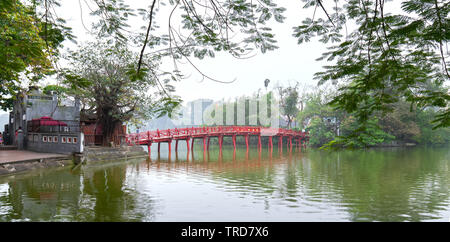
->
<box><xmin>149</xmin><ymin>148</ymin><xmax>450</xmax><ymax>221</ymax></box>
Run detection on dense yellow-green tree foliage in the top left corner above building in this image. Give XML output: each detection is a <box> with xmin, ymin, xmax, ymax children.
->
<box><xmin>0</xmin><ymin>0</ymin><xmax>70</xmax><ymax>110</ymax></box>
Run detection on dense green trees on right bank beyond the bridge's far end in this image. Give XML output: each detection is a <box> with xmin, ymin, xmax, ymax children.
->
<box><xmin>297</xmin><ymin>85</ymin><xmax>450</xmax><ymax>148</ymax></box>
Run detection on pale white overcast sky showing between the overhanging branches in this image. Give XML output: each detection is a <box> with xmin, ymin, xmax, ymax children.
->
<box><xmin>57</xmin><ymin>0</ymin><xmax>326</xmax><ymax>102</ymax></box>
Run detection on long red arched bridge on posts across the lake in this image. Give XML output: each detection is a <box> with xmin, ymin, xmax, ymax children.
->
<box><xmin>126</xmin><ymin>126</ymin><xmax>309</xmax><ymax>154</ymax></box>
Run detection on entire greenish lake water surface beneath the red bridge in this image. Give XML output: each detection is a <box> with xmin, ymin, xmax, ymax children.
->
<box><xmin>0</xmin><ymin>145</ymin><xmax>450</xmax><ymax>221</ymax></box>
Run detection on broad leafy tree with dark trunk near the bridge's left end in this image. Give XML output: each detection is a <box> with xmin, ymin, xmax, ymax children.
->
<box><xmin>64</xmin><ymin>41</ymin><xmax>179</xmax><ymax>144</ymax></box>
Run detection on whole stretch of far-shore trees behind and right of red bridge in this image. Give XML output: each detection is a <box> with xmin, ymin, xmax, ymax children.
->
<box><xmin>192</xmin><ymin>84</ymin><xmax>450</xmax><ymax>149</ymax></box>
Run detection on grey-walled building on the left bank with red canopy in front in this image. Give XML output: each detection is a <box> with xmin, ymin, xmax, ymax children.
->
<box><xmin>8</xmin><ymin>89</ymin><xmax>84</xmax><ymax>154</ymax></box>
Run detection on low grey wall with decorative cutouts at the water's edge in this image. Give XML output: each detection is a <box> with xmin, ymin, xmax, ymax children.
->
<box><xmin>26</xmin><ymin>133</ymin><xmax>84</xmax><ymax>154</ymax></box>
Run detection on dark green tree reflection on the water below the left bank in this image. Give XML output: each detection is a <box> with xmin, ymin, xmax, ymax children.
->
<box><xmin>0</xmin><ymin>158</ymin><xmax>153</xmax><ymax>221</ymax></box>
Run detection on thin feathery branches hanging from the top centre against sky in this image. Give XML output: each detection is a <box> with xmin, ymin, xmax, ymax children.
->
<box><xmin>83</xmin><ymin>0</ymin><xmax>285</xmax><ymax>82</ymax></box>
